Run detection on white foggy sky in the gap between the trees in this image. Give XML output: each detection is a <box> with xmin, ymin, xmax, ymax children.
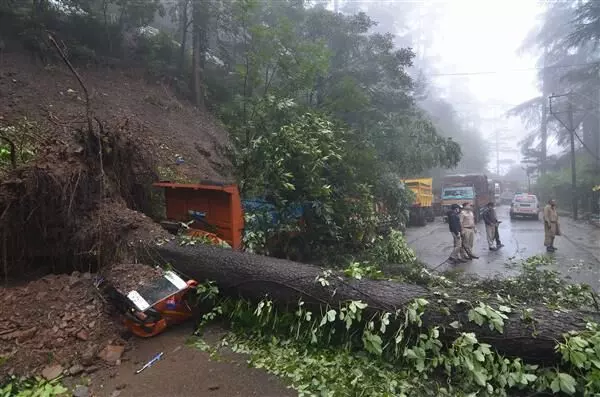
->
<box><xmin>432</xmin><ymin>0</ymin><xmax>543</xmax><ymax>172</ymax></box>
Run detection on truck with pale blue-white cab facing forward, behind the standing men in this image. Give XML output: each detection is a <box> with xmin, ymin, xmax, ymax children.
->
<box><xmin>442</xmin><ymin>174</ymin><xmax>494</xmax><ymax>222</ymax></box>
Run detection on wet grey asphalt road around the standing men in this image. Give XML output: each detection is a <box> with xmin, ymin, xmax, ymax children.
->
<box><xmin>406</xmin><ymin>206</ymin><xmax>600</xmax><ymax>290</ymax></box>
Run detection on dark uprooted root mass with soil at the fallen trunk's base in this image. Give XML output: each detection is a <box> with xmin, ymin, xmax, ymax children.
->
<box><xmin>0</xmin><ymin>113</ymin><xmax>168</xmax><ymax>276</ymax></box>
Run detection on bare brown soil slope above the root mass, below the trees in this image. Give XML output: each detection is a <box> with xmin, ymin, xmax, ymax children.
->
<box><xmin>0</xmin><ymin>52</ymin><xmax>233</xmax><ymax>182</ymax></box>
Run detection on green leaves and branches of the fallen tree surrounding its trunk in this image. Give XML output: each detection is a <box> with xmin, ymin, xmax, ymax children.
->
<box><xmin>193</xmin><ymin>234</ymin><xmax>600</xmax><ymax>397</ymax></box>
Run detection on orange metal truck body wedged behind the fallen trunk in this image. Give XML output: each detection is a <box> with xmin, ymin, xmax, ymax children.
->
<box><xmin>154</xmin><ymin>182</ymin><xmax>244</xmax><ymax>250</ymax></box>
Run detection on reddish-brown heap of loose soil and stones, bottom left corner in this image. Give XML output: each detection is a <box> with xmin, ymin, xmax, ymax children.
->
<box><xmin>0</xmin><ymin>272</ymin><xmax>125</xmax><ymax>376</ymax></box>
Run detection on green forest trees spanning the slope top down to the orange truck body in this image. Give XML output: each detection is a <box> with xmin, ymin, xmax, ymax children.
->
<box><xmin>1</xmin><ymin>0</ymin><xmax>462</xmax><ymax>254</ymax></box>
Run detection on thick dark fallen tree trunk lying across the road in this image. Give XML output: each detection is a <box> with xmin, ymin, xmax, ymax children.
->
<box><xmin>149</xmin><ymin>243</ymin><xmax>600</xmax><ymax>363</ymax></box>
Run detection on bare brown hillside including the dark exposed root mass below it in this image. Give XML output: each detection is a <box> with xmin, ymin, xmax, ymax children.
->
<box><xmin>0</xmin><ymin>50</ymin><xmax>232</xmax><ymax>280</ymax></box>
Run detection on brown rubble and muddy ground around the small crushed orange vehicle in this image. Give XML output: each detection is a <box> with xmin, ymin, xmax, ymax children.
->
<box><xmin>0</xmin><ymin>264</ymin><xmax>296</xmax><ymax>397</ymax></box>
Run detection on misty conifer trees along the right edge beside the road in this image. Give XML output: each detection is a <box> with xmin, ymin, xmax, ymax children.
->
<box><xmin>510</xmin><ymin>1</ymin><xmax>600</xmax><ymax>211</ymax></box>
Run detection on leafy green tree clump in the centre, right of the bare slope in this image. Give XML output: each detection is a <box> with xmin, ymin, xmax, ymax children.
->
<box><xmin>203</xmin><ymin>2</ymin><xmax>461</xmax><ymax>252</ymax></box>
